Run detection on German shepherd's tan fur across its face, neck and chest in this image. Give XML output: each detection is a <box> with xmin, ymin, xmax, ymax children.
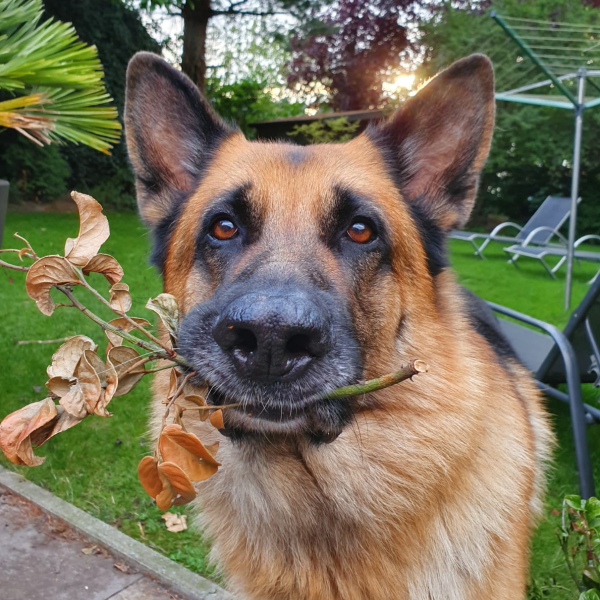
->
<box><xmin>125</xmin><ymin>52</ymin><xmax>552</xmax><ymax>600</ymax></box>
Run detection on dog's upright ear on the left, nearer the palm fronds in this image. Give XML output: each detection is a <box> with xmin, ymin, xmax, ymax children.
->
<box><xmin>125</xmin><ymin>52</ymin><xmax>233</xmax><ymax>227</ymax></box>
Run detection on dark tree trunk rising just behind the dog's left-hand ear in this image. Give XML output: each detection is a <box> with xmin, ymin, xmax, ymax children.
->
<box><xmin>181</xmin><ymin>0</ymin><xmax>212</xmax><ymax>91</ymax></box>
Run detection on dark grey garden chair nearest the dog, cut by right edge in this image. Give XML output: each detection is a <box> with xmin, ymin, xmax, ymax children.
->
<box><xmin>488</xmin><ymin>277</ymin><xmax>600</xmax><ymax>498</ymax></box>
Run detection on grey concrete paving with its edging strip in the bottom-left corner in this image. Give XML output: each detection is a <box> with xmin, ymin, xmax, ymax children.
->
<box><xmin>0</xmin><ymin>466</ymin><xmax>234</xmax><ymax>600</ymax></box>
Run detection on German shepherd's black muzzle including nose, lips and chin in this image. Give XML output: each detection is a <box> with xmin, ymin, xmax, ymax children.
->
<box><xmin>179</xmin><ymin>274</ymin><xmax>360</xmax><ymax>441</ymax></box>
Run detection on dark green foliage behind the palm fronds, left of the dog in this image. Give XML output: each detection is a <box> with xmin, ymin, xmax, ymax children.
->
<box><xmin>0</xmin><ymin>0</ymin><xmax>160</xmax><ymax>209</ymax></box>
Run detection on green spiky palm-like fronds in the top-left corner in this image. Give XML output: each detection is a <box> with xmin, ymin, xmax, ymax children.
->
<box><xmin>0</xmin><ymin>0</ymin><xmax>121</xmax><ymax>154</ymax></box>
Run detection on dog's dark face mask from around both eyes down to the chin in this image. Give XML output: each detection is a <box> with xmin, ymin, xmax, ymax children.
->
<box><xmin>173</xmin><ymin>182</ymin><xmax>396</xmax><ymax>441</ymax></box>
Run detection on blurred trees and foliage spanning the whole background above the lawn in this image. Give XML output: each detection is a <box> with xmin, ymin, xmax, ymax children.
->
<box><xmin>0</xmin><ymin>0</ymin><xmax>600</xmax><ymax>234</ymax></box>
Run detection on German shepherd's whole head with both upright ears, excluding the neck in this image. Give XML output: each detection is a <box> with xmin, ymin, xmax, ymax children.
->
<box><xmin>125</xmin><ymin>53</ymin><xmax>494</xmax><ymax>441</ymax></box>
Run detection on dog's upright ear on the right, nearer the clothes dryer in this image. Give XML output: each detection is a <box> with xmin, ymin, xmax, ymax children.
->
<box><xmin>369</xmin><ymin>54</ymin><xmax>494</xmax><ymax>230</ymax></box>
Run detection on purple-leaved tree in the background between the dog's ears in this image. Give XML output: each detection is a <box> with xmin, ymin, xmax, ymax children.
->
<box><xmin>288</xmin><ymin>0</ymin><xmax>418</xmax><ymax>111</ymax></box>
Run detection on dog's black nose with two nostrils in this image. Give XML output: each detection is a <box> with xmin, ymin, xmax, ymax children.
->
<box><xmin>213</xmin><ymin>290</ymin><xmax>331</xmax><ymax>383</ymax></box>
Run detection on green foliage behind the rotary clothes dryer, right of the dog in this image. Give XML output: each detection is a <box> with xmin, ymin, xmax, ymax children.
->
<box><xmin>419</xmin><ymin>0</ymin><xmax>600</xmax><ymax>235</ymax></box>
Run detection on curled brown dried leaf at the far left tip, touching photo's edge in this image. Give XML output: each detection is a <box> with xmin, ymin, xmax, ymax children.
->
<box><xmin>0</xmin><ymin>398</ymin><xmax>57</xmax><ymax>467</ymax></box>
